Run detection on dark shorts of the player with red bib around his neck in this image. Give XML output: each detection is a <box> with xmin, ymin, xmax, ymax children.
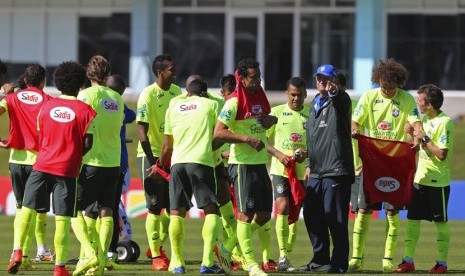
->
<box><xmin>228</xmin><ymin>164</ymin><xmax>273</xmax><ymax>213</ymax></box>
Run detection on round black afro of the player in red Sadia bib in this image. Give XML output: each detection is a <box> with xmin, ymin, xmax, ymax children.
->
<box><xmin>53</xmin><ymin>61</ymin><xmax>86</xmax><ymax>96</ymax></box>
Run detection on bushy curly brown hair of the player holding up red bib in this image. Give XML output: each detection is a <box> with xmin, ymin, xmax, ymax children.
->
<box><xmin>371</xmin><ymin>58</ymin><xmax>409</xmax><ymax>87</ymax></box>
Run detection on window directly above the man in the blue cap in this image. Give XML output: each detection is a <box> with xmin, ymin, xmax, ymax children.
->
<box><xmin>300</xmin><ymin>14</ymin><xmax>355</xmax><ymax>89</ymax></box>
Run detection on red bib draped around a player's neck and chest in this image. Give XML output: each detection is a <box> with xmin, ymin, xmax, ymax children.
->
<box><xmin>228</xmin><ymin>70</ymin><xmax>271</xmax><ymax>120</ymax></box>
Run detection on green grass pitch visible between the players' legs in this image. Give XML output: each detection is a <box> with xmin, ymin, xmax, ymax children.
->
<box><xmin>0</xmin><ymin>217</ymin><xmax>465</xmax><ymax>275</ymax></box>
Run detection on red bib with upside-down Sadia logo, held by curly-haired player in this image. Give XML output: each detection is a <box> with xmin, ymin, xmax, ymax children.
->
<box><xmin>356</xmin><ymin>135</ymin><xmax>416</xmax><ymax>206</ymax></box>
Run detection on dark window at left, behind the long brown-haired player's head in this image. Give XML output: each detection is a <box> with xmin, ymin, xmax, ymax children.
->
<box><xmin>79</xmin><ymin>13</ymin><xmax>131</xmax><ymax>84</ymax></box>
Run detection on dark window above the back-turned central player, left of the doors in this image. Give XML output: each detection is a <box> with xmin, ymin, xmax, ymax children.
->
<box><xmin>163</xmin><ymin>13</ymin><xmax>225</xmax><ymax>87</ymax></box>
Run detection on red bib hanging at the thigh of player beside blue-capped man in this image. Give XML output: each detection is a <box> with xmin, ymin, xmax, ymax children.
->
<box><xmin>287</xmin><ymin>156</ymin><xmax>306</xmax><ymax>224</ymax></box>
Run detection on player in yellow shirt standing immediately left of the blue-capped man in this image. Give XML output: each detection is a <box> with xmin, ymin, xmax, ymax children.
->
<box><xmin>266</xmin><ymin>77</ymin><xmax>309</xmax><ymax>271</ymax></box>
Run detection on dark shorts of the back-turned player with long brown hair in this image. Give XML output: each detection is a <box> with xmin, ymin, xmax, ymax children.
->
<box><xmin>77</xmin><ymin>165</ymin><xmax>120</xmax><ymax>211</ymax></box>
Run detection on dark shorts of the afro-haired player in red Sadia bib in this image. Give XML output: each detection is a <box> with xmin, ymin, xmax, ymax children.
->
<box><xmin>23</xmin><ymin>170</ymin><xmax>77</xmax><ymax>217</ymax></box>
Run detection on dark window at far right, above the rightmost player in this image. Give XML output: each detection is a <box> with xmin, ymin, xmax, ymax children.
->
<box><xmin>387</xmin><ymin>14</ymin><xmax>465</xmax><ymax>90</ymax></box>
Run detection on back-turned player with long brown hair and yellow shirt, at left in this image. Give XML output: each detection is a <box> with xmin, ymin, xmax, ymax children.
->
<box><xmin>72</xmin><ymin>55</ymin><xmax>124</xmax><ymax>275</ymax></box>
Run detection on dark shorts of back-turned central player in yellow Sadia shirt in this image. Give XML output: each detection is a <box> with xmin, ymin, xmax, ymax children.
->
<box><xmin>169</xmin><ymin>163</ymin><xmax>217</xmax><ymax>210</ymax></box>
